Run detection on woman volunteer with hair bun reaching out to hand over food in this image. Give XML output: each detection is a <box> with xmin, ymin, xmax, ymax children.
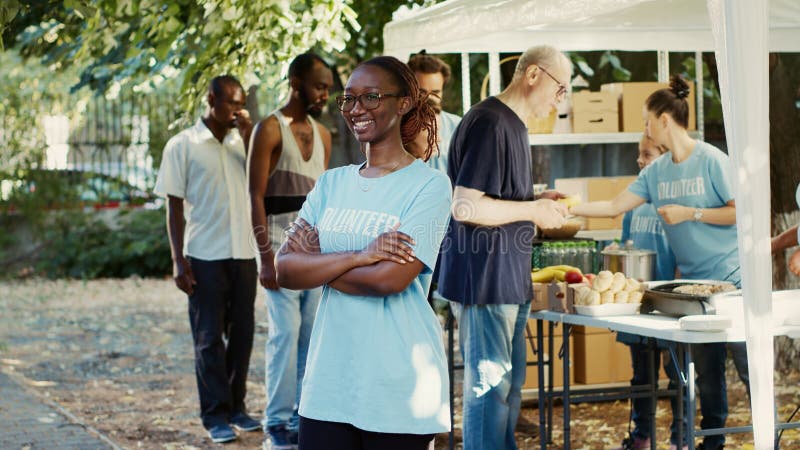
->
<box><xmin>570</xmin><ymin>75</ymin><xmax>747</xmax><ymax>450</ymax></box>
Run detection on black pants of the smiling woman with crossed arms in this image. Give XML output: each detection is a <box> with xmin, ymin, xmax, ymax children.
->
<box><xmin>299</xmin><ymin>416</ymin><xmax>434</xmax><ymax>450</ymax></box>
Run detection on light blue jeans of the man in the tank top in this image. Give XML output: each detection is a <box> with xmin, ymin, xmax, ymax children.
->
<box><xmin>264</xmin><ymin>288</ymin><xmax>322</xmax><ymax>430</ymax></box>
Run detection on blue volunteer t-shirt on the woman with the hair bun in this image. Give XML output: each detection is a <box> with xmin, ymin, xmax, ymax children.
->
<box><xmin>628</xmin><ymin>141</ymin><xmax>741</xmax><ymax>284</ymax></box>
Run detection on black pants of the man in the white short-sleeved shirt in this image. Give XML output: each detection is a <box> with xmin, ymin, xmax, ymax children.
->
<box><xmin>189</xmin><ymin>258</ymin><xmax>258</xmax><ymax>428</ymax></box>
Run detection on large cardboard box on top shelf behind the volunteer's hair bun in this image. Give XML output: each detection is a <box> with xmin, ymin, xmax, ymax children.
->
<box><xmin>600</xmin><ymin>81</ymin><xmax>697</xmax><ymax>133</ymax></box>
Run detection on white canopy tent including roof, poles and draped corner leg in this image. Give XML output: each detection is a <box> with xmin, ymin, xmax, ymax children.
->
<box><xmin>384</xmin><ymin>0</ymin><xmax>800</xmax><ymax>450</ymax></box>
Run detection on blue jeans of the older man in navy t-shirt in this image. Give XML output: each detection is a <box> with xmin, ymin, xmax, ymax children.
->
<box><xmin>450</xmin><ymin>302</ymin><xmax>531</xmax><ymax>450</ymax></box>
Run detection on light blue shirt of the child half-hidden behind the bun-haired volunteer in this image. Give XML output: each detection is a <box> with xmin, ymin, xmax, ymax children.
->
<box><xmin>622</xmin><ymin>203</ymin><xmax>675</xmax><ymax>280</ymax></box>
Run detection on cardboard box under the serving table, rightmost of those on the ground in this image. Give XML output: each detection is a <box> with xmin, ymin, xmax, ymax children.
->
<box><xmin>572</xmin><ymin>328</ymin><xmax>633</xmax><ymax>384</ymax></box>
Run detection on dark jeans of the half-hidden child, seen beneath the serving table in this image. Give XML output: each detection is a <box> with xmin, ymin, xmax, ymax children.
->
<box><xmin>628</xmin><ymin>341</ymin><xmax>687</xmax><ymax>446</ymax></box>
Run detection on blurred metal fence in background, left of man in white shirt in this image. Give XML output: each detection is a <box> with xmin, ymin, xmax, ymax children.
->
<box><xmin>0</xmin><ymin>91</ymin><xmax>180</xmax><ymax>207</ymax></box>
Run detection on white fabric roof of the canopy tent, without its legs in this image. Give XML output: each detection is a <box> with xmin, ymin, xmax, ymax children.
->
<box><xmin>383</xmin><ymin>0</ymin><xmax>800</xmax><ymax>60</ymax></box>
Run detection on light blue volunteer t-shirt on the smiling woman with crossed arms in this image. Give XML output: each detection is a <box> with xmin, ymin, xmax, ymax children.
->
<box><xmin>300</xmin><ymin>160</ymin><xmax>452</xmax><ymax>434</ymax></box>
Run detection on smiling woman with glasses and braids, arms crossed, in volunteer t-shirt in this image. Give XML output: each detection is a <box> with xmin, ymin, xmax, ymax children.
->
<box><xmin>276</xmin><ymin>56</ymin><xmax>451</xmax><ymax>450</ymax></box>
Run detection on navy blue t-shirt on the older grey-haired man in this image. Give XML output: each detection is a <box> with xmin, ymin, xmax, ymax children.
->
<box><xmin>439</xmin><ymin>97</ymin><xmax>534</xmax><ymax>305</ymax></box>
